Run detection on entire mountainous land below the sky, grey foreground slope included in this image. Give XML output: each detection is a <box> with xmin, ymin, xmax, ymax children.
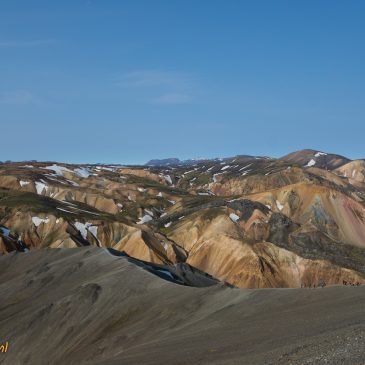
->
<box><xmin>0</xmin><ymin>150</ymin><xmax>365</xmax><ymax>365</ymax></box>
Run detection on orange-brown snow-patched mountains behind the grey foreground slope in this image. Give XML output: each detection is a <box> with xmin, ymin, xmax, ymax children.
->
<box><xmin>0</xmin><ymin>150</ymin><xmax>365</xmax><ymax>288</ymax></box>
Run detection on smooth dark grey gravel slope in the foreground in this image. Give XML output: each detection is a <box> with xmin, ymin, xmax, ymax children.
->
<box><xmin>0</xmin><ymin>247</ymin><xmax>365</xmax><ymax>365</ymax></box>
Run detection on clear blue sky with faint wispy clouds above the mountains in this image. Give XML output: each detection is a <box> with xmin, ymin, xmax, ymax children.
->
<box><xmin>0</xmin><ymin>0</ymin><xmax>365</xmax><ymax>164</ymax></box>
